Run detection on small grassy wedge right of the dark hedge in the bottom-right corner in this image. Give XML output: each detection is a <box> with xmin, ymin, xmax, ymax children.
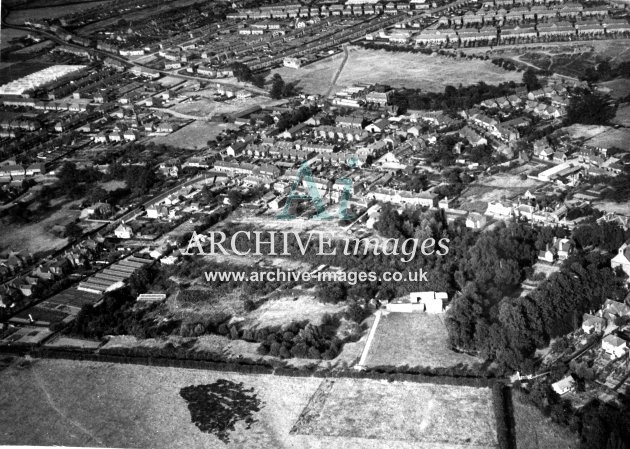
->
<box><xmin>513</xmin><ymin>388</ymin><xmax>579</xmax><ymax>449</ymax></box>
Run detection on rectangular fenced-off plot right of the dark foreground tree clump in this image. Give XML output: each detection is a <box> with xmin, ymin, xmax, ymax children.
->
<box><xmin>292</xmin><ymin>379</ymin><xmax>497</xmax><ymax>447</ymax></box>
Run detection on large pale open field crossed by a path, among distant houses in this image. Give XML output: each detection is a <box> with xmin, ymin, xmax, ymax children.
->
<box><xmin>278</xmin><ymin>48</ymin><xmax>522</xmax><ymax>94</ymax></box>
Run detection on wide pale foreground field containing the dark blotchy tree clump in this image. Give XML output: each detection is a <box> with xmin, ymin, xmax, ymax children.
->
<box><xmin>0</xmin><ymin>359</ymin><xmax>497</xmax><ymax>449</ymax></box>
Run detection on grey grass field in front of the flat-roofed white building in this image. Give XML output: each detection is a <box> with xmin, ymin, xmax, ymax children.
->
<box><xmin>365</xmin><ymin>312</ymin><xmax>480</xmax><ymax>368</ymax></box>
